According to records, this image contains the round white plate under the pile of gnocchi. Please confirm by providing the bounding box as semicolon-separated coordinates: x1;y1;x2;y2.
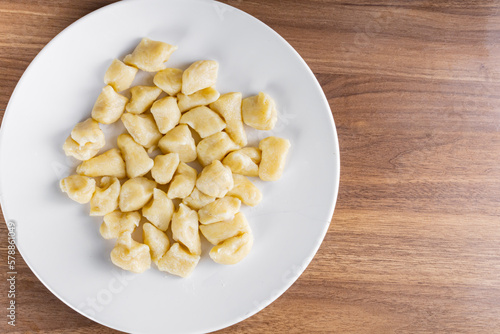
0;0;339;333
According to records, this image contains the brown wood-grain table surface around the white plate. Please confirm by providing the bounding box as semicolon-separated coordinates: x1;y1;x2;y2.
0;0;500;333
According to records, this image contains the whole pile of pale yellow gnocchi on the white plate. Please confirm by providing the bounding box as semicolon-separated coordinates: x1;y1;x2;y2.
60;38;290;277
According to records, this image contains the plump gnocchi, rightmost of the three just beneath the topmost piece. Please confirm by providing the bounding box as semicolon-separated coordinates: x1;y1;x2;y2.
182;60;219;95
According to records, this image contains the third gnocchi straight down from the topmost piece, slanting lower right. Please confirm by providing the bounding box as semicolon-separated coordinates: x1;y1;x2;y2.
121;113;161;148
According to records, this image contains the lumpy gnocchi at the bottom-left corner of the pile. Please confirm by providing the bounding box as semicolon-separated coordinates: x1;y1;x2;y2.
111;233;151;273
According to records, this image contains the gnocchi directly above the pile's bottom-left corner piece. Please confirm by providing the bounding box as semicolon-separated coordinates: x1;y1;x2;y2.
99;210;141;239
